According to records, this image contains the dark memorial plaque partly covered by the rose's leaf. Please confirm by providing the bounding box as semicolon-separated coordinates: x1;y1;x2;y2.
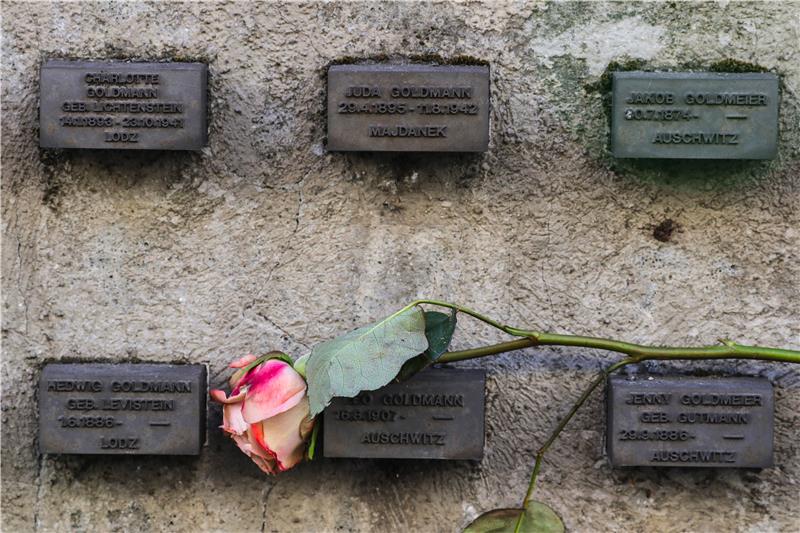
323;369;486;460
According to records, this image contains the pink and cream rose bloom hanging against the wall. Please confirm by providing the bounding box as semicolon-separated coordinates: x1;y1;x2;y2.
211;355;314;474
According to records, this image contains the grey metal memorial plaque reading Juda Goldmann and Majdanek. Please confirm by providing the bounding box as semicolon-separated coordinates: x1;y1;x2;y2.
328;65;489;152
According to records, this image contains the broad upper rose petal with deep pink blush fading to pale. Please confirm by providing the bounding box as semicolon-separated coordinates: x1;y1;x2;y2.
240;359;306;424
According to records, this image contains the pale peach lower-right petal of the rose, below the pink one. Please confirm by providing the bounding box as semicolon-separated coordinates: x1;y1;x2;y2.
254;397;309;471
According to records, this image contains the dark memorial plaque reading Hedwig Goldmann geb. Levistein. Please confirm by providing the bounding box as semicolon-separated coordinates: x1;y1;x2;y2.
39;363;206;455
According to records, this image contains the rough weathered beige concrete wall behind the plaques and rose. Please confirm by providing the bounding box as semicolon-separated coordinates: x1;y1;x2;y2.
2;2;800;531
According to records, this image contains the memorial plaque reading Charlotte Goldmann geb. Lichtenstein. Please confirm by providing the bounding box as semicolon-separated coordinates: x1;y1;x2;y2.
39;59;207;150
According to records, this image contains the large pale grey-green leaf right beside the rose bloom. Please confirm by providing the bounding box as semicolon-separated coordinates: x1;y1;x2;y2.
306;306;428;416
